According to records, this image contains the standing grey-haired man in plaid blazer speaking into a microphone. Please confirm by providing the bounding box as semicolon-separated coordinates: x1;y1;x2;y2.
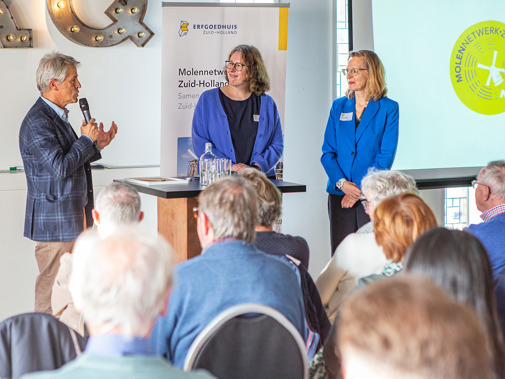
19;52;117;313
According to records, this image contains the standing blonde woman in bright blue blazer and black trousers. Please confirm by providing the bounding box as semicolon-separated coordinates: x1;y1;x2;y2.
321;50;399;255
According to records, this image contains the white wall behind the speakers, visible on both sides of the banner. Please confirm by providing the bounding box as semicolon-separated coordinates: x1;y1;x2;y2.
0;0;334;320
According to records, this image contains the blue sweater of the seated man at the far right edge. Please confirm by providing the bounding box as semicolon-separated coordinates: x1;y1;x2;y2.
466;213;505;275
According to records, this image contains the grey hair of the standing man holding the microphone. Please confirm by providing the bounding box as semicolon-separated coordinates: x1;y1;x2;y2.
36;51;80;95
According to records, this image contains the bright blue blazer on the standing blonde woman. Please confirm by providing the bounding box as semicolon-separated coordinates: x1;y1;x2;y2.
321;97;399;195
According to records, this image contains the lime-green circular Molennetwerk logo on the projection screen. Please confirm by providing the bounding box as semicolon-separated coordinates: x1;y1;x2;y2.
451;21;505;115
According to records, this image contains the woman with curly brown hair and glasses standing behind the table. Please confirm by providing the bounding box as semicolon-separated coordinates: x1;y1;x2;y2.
192;45;284;177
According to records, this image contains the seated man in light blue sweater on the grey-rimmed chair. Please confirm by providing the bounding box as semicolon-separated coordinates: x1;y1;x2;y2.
152;176;305;367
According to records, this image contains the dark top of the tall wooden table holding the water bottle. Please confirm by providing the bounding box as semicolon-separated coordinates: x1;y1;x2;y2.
114;178;307;199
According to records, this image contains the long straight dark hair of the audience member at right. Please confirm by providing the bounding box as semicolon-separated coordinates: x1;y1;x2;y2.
405;228;505;378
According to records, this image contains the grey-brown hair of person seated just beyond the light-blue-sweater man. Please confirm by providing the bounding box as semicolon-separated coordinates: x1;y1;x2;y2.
240;168;282;228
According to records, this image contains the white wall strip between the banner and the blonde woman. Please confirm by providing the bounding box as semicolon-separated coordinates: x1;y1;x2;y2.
283;0;335;277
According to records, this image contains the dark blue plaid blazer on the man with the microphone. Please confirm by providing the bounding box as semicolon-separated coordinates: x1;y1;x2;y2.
19;98;101;242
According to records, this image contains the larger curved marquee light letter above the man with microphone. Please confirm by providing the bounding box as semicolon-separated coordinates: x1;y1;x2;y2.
47;0;154;47
